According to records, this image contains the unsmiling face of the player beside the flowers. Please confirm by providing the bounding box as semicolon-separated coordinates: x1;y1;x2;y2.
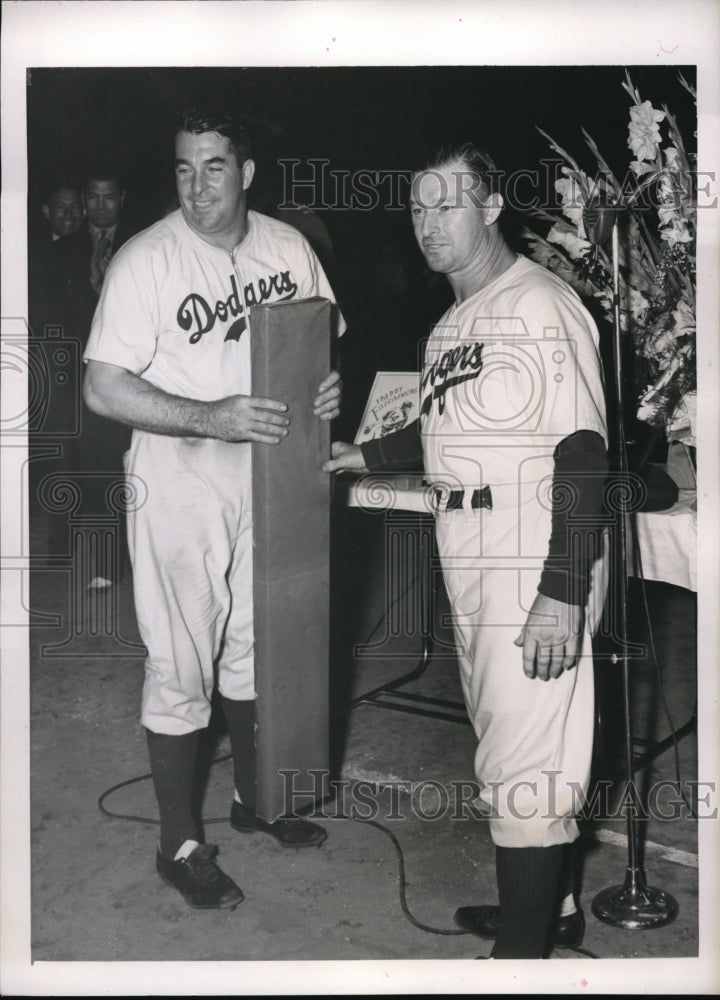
410;162;496;274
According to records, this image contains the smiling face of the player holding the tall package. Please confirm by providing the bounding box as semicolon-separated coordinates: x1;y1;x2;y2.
175;132;255;250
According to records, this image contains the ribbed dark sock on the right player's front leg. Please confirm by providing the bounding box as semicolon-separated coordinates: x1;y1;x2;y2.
492;844;565;958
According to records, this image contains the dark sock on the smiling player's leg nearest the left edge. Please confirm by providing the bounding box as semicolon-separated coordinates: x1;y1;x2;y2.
146;729;200;861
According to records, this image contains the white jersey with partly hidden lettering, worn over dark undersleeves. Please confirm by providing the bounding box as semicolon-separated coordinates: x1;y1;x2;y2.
420;256;607;487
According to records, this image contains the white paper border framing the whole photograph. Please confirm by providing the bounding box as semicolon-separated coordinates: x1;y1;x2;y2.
0;0;720;996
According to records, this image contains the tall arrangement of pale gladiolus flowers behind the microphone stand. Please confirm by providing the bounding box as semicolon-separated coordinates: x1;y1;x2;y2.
524;72;697;434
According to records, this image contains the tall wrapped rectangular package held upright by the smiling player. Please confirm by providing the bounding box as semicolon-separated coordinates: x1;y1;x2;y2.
250;298;331;822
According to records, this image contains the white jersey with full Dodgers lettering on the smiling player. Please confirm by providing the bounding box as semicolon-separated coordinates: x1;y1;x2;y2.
84;209;344;401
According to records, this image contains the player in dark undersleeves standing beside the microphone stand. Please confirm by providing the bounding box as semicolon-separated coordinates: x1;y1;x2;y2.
326;144;607;958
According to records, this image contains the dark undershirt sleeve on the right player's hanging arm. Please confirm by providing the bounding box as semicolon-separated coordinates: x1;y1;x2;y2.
538;431;608;606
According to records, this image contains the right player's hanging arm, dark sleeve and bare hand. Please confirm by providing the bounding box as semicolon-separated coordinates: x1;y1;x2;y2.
515;430;608;680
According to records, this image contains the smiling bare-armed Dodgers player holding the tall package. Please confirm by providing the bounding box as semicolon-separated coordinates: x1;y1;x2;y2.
85;108;342;908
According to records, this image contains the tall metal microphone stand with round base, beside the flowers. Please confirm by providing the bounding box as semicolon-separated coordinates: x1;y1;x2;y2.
583;200;678;930
